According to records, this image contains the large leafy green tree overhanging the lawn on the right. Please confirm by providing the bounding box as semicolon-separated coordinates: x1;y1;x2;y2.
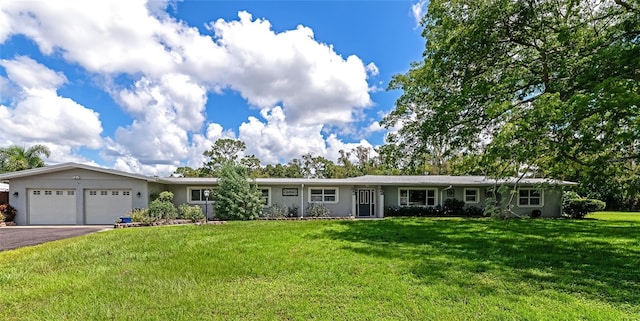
383;0;640;192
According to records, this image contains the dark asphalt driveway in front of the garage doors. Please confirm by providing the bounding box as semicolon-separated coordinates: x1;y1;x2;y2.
0;225;110;251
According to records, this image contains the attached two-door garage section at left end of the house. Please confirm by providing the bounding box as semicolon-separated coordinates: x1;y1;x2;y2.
0;163;154;225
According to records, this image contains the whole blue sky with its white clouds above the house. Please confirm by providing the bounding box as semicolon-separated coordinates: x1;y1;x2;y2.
0;0;426;175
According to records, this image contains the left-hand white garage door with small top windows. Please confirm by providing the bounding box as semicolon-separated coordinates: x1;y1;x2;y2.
29;189;76;224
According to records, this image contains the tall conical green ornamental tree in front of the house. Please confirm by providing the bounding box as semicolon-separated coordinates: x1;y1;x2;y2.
213;162;262;220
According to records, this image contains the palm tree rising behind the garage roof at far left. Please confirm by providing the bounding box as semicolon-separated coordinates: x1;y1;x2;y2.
0;145;51;172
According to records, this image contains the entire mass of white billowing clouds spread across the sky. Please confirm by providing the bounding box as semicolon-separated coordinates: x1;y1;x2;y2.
0;0;379;172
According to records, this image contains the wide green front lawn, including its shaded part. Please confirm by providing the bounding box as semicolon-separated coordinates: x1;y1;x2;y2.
0;214;640;320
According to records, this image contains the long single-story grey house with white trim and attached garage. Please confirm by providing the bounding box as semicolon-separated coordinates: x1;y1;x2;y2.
0;163;575;225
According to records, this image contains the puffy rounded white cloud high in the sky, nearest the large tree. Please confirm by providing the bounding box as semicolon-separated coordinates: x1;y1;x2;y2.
210;12;375;125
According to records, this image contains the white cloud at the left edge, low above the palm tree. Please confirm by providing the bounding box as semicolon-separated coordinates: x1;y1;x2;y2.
0;57;102;162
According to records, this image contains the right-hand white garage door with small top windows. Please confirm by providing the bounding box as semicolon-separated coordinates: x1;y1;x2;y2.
84;189;132;224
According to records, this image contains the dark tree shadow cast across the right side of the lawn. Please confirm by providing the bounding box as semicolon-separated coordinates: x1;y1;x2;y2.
321;219;640;305
